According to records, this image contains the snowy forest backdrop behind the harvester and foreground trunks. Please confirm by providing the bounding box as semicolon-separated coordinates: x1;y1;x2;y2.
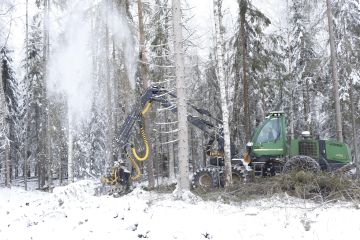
0;0;360;188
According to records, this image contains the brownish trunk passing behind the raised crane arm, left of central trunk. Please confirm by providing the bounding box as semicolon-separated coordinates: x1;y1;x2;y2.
137;0;155;189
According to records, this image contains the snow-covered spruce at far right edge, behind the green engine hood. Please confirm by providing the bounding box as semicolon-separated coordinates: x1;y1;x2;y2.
332;0;360;171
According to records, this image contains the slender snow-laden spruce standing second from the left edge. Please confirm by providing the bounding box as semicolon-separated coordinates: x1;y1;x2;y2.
21;14;46;188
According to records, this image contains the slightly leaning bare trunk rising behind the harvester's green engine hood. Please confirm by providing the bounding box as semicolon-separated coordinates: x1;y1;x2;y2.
326;0;343;142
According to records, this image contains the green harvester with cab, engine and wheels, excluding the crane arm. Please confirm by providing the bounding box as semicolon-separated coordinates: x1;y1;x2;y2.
192;112;352;188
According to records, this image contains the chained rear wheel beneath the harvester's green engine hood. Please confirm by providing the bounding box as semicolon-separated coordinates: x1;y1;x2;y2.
283;155;320;172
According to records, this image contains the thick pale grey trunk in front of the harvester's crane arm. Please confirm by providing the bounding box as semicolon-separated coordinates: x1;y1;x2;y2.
172;0;190;192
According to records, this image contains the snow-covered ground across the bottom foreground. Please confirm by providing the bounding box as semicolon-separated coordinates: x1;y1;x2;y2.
0;181;360;240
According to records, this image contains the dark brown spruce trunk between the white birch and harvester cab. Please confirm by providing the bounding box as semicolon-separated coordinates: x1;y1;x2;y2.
239;0;251;142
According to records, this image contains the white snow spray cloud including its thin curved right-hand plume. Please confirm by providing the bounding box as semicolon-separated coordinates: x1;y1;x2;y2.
48;0;137;124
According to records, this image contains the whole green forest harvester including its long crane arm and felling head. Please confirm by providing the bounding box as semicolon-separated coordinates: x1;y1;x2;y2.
102;86;352;192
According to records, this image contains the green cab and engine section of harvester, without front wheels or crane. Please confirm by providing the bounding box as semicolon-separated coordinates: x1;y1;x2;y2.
244;112;352;175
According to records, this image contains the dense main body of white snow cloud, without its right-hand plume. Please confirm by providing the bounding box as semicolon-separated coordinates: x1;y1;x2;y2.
48;1;93;123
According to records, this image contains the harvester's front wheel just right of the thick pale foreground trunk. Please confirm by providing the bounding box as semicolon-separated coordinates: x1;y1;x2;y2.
192;167;219;189
